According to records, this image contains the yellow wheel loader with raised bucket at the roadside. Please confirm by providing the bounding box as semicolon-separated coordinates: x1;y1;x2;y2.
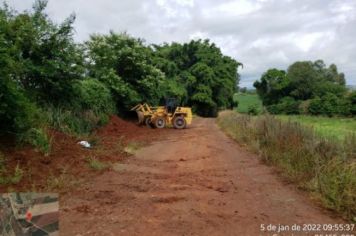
131;98;193;129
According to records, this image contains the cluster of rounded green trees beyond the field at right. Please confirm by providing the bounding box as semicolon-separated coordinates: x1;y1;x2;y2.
254;60;356;116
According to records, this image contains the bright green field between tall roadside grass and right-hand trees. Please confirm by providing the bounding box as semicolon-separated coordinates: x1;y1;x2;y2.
277;115;356;140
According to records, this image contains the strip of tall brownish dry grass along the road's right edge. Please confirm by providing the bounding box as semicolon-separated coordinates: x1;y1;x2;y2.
218;112;356;219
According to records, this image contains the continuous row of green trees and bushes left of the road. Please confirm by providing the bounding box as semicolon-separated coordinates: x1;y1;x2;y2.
0;0;241;144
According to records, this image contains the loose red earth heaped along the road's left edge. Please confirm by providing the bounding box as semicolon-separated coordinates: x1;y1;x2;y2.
0;116;167;192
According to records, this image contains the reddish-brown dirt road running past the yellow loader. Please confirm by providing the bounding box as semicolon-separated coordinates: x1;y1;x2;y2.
60;118;340;236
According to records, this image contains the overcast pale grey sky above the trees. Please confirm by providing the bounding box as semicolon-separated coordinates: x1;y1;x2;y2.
0;0;356;87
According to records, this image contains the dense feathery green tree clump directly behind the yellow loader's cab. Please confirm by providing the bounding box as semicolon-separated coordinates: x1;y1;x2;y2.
154;40;242;116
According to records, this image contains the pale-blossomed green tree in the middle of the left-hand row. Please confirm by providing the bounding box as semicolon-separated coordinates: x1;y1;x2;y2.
85;32;165;113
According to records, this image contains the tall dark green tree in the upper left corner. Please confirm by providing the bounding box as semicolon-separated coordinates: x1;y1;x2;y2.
0;0;84;104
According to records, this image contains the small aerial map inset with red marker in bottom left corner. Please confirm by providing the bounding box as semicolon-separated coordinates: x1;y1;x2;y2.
0;193;59;236
